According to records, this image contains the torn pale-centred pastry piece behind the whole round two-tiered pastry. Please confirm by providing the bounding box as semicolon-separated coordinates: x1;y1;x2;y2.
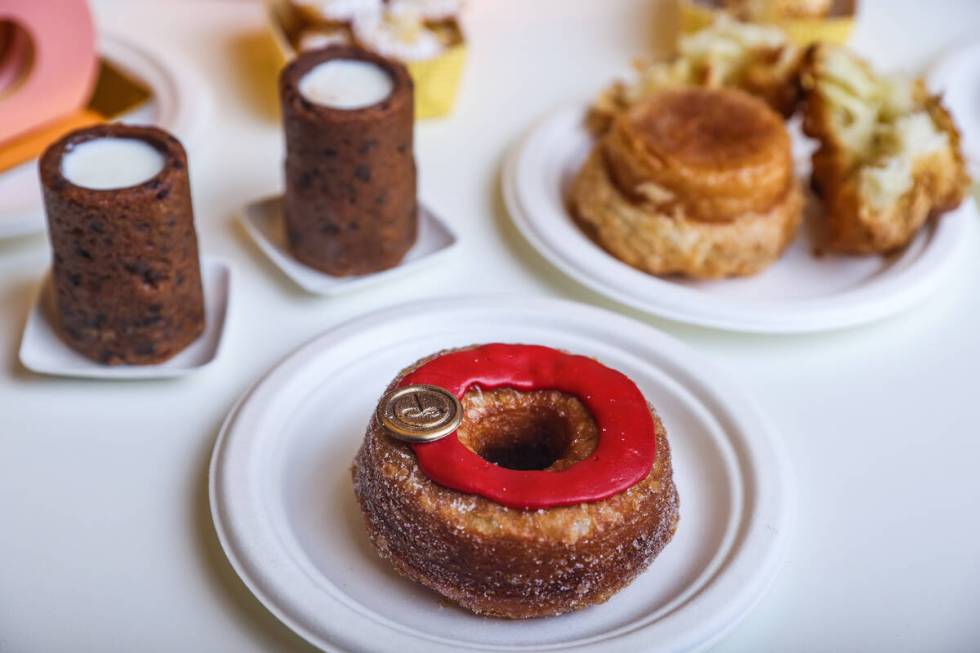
591;14;802;132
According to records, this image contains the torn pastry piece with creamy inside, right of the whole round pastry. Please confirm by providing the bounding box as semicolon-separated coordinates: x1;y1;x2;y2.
801;44;969;254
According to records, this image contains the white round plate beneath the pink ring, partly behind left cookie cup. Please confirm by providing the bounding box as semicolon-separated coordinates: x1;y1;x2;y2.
0;30;209;240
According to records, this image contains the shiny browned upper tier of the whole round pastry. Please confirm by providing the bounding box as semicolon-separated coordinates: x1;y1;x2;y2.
601;88;793;222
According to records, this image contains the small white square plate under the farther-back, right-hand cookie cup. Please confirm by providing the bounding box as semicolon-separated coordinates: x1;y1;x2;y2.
241;196;456;295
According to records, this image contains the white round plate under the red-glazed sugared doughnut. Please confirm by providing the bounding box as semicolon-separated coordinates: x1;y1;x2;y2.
210;297;793;653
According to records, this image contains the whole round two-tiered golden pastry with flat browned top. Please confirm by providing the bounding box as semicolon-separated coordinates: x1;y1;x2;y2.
571;88;803;279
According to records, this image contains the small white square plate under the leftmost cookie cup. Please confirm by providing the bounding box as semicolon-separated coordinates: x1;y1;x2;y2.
20;260;231;379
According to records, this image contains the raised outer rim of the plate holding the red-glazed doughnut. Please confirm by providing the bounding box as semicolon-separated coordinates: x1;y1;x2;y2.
208;294;796;653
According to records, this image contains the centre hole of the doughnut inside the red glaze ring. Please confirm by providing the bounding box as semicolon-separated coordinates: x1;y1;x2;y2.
456;388;599;472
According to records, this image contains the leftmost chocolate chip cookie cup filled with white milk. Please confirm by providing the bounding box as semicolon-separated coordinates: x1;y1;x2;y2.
40;124;205;365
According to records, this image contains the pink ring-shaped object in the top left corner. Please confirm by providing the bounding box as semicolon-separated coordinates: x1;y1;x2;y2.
0;0;98;143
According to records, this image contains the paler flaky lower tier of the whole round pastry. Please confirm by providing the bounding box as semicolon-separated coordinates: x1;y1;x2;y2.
571;150;803;279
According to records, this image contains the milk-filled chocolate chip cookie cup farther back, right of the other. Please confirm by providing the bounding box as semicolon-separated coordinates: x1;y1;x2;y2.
279;46;418;276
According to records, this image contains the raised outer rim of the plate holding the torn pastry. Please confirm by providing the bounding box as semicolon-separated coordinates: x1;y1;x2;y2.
500;103;977;334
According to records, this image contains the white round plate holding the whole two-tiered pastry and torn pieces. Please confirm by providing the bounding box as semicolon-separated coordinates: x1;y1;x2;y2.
503;108;976;333
